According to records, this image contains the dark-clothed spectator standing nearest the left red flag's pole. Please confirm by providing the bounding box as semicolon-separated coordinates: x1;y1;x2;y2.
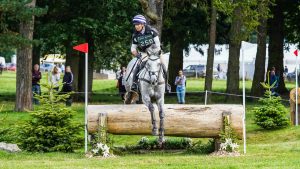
62;66;73;106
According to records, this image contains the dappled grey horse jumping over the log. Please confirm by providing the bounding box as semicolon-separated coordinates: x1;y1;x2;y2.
125;53;165;146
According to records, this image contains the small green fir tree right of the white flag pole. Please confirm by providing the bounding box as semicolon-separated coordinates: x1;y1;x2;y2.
253;91;290;129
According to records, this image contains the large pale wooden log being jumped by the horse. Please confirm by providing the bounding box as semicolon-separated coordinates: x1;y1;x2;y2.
88;104;243;138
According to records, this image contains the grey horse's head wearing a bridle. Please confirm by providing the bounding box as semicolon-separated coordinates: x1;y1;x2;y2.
145;54;162;85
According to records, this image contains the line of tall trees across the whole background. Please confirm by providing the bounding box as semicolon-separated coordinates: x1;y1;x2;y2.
0;0;300;111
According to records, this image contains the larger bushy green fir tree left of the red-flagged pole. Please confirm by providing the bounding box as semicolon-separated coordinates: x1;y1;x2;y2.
19;84;82;152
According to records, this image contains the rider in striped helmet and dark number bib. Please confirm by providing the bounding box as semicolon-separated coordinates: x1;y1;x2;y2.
131;15;167;92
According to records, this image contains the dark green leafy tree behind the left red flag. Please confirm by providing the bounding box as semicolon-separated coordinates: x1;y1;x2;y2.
34;0;141;100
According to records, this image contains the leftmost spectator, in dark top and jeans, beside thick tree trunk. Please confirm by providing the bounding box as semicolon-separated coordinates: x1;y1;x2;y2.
32;64;42;105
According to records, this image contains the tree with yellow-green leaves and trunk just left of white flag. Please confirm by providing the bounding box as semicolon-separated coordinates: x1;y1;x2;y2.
216;0;272;100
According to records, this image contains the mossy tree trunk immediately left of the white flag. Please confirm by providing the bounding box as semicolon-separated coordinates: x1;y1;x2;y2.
226;4;242;101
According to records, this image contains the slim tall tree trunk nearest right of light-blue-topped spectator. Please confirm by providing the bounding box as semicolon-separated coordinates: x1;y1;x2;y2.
204;0;217;103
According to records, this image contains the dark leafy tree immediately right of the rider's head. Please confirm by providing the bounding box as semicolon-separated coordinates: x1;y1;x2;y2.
162;0;208;91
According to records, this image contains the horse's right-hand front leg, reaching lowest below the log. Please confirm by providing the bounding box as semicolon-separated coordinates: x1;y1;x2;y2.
156;95;165;146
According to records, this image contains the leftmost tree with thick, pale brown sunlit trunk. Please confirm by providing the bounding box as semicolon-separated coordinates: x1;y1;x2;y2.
6;0;43;111
